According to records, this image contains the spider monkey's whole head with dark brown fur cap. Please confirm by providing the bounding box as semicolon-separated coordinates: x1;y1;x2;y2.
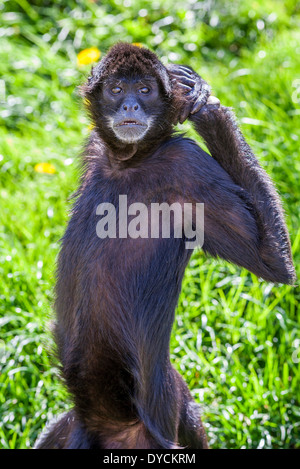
81;43;180;159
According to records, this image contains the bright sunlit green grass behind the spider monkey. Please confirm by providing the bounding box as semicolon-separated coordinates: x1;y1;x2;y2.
0;0;300;448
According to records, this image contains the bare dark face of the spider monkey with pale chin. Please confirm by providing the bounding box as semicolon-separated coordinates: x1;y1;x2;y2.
101;77;162;143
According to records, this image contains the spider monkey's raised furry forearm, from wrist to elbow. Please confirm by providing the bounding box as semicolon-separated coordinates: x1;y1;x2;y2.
190;98;295;284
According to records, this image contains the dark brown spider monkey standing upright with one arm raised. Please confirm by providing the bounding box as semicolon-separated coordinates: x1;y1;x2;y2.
36;43;295;449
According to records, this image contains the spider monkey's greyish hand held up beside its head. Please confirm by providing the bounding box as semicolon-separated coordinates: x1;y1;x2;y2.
168;64;214;124
